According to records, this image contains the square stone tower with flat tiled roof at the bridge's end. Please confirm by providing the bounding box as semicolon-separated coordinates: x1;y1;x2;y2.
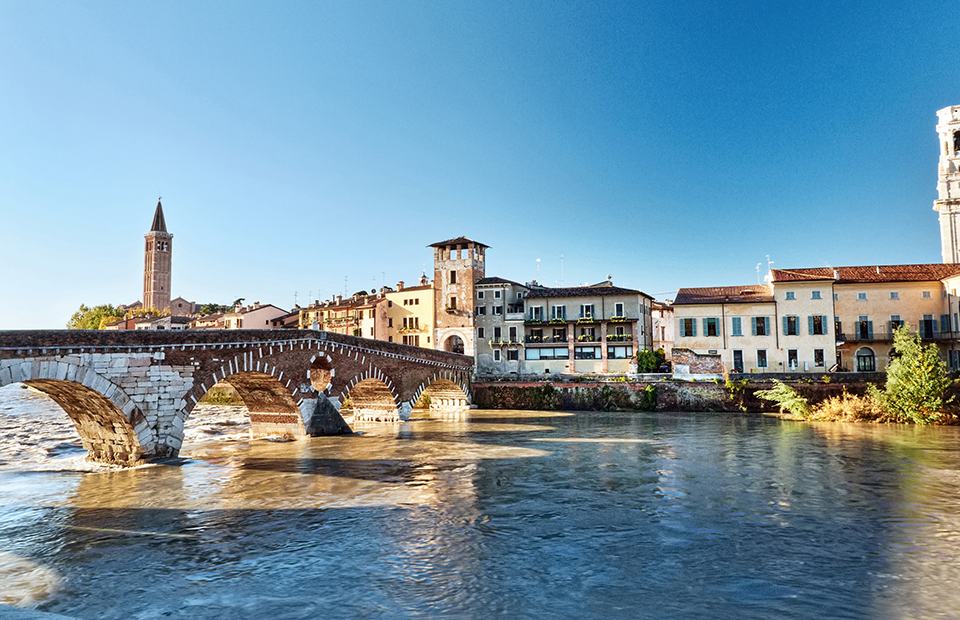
430;237;488;357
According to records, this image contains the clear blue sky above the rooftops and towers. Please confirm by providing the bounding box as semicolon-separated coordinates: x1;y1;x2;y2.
0;0;960;329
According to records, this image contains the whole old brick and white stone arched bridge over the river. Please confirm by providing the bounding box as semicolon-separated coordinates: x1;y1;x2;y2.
0;329;473;465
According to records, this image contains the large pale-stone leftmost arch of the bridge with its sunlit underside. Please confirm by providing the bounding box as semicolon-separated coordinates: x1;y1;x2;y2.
0;361;150;466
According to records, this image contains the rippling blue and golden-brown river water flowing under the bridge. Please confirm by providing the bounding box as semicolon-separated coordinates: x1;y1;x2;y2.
0;386;960;620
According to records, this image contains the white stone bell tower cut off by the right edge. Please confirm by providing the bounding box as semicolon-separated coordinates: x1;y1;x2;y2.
933;106;960;263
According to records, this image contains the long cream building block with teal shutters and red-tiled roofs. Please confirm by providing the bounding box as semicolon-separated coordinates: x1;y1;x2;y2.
673;264;960;373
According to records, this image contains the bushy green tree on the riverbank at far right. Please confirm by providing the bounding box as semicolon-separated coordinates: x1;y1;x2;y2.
870;325;953;424
